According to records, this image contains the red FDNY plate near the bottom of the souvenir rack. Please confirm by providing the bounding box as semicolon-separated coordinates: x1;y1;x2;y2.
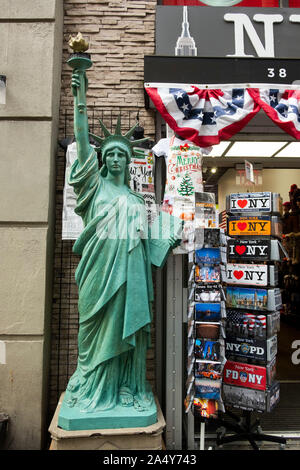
223;361;267;390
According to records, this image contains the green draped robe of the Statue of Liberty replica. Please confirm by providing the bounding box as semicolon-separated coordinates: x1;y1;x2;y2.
65;149;153;411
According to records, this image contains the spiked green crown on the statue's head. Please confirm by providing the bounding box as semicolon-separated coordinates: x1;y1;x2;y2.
89;116;148;157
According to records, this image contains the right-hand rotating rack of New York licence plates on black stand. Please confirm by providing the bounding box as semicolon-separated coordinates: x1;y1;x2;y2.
217;193;286;450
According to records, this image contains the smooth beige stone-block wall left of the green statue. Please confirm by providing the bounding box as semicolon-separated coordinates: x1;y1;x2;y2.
0;0;63;450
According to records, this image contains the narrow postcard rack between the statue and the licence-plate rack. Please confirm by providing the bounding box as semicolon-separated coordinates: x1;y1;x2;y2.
184;193;226;449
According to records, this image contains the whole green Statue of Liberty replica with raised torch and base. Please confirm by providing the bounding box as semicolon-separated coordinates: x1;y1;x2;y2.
58;34;181;430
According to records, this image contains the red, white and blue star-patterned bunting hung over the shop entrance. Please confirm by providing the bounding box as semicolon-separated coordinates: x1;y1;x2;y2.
145;84;300;147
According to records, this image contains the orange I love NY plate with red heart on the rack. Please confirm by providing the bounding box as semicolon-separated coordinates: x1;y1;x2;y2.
228;216;272;236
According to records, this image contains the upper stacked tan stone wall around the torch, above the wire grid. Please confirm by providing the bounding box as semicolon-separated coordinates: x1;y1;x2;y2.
61;0;156;136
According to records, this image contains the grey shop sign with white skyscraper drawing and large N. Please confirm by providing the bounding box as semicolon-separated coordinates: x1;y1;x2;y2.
156;6;300;59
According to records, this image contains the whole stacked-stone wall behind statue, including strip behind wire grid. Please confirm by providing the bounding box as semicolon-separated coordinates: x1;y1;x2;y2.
49;0;156;420
